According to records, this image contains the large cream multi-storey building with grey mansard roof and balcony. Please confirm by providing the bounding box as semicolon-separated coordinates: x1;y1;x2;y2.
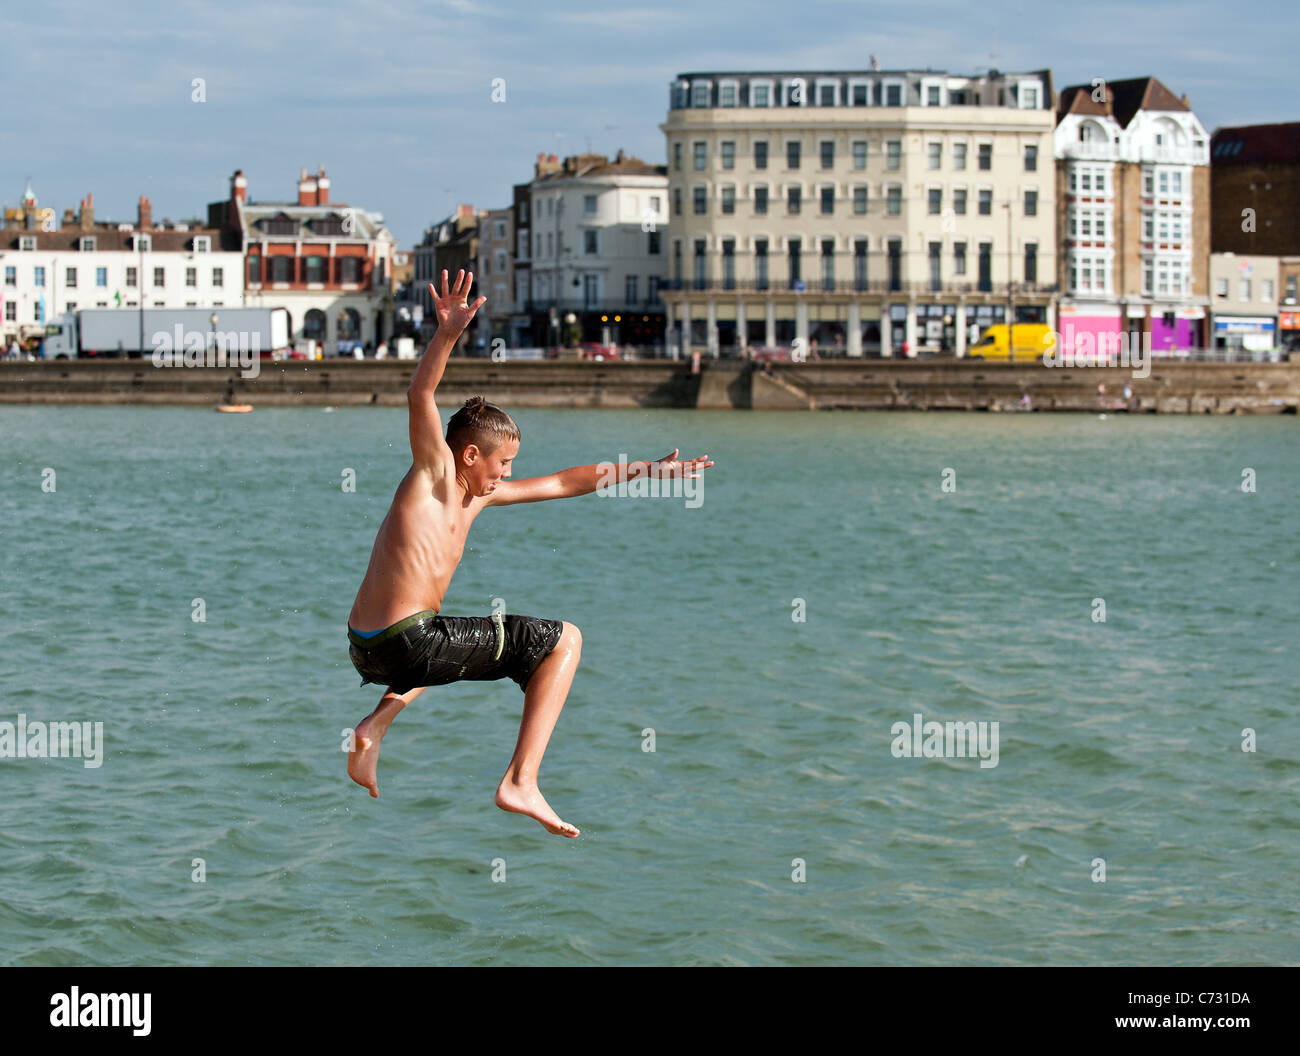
660;69;1057;356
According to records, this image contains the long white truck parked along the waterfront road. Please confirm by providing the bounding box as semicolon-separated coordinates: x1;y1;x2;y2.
44;308;291;359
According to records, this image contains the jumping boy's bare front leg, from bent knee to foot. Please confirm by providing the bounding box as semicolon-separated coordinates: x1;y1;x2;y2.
493;623;582;838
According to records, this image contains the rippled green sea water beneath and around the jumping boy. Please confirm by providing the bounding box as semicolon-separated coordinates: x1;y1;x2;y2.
0;407;1300;965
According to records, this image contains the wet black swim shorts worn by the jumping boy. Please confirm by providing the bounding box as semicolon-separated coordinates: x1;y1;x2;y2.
347;609;564;693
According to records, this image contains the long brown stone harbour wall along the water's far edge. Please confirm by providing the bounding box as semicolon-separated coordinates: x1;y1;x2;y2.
0;359;1300;414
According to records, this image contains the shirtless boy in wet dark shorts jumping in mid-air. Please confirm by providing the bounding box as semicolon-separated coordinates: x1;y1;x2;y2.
347;271;714;836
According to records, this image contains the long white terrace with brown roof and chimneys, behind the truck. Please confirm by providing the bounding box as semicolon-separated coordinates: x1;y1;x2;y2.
0;185;244;342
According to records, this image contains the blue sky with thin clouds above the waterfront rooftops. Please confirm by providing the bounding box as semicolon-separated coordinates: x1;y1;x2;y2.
0;0;1300;246
